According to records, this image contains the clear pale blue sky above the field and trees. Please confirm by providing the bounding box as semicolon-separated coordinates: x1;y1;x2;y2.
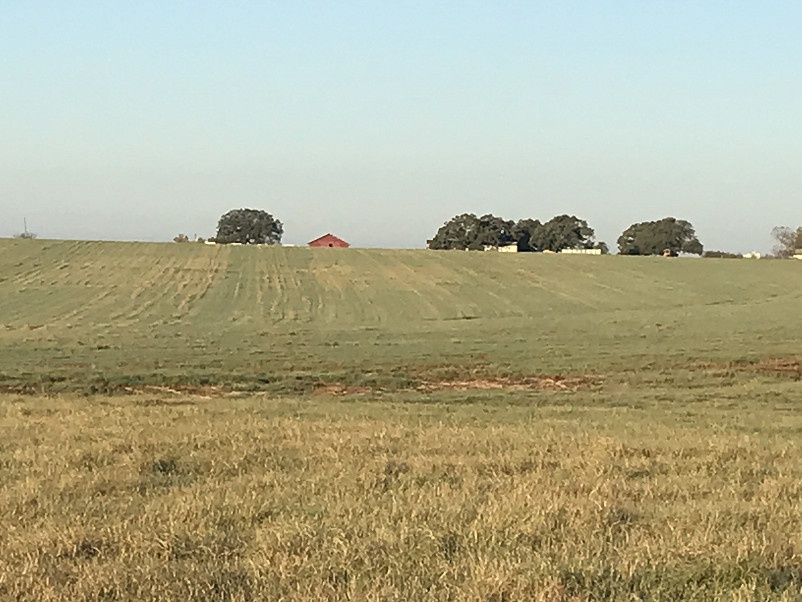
0;0;802;251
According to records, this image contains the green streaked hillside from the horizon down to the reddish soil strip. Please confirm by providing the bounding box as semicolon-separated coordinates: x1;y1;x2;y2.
0;239;802;392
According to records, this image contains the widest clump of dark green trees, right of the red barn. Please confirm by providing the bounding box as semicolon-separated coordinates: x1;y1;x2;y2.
428;213;607;252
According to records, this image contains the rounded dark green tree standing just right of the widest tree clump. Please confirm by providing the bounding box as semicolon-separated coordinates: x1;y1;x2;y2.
618;217;703;255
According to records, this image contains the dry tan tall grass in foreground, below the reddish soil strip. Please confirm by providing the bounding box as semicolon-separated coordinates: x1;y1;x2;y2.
0;385;802;602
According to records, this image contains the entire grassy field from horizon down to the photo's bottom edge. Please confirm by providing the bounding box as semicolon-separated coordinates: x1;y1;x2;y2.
0;240;802;602
